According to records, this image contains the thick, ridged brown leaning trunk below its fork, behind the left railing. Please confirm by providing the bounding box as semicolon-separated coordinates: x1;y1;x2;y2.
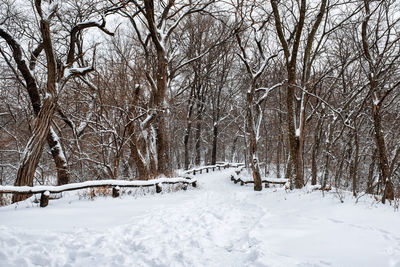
12;96;56;203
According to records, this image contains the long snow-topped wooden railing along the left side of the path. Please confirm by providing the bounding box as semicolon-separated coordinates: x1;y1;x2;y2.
0;163;244;207
